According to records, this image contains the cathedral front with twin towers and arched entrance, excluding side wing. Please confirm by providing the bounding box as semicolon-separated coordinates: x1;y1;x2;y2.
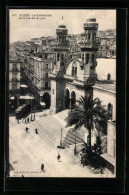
49;17;99;114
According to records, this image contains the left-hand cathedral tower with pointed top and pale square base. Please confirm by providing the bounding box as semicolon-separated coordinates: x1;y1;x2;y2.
49;17;68;114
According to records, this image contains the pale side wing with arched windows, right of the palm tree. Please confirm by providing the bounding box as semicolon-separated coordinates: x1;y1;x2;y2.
93;82;116;176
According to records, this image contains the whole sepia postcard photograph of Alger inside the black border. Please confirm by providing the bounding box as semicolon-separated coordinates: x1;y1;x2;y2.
8;9;117;178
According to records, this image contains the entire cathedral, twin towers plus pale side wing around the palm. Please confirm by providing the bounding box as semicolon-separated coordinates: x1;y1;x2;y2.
49;18;116;175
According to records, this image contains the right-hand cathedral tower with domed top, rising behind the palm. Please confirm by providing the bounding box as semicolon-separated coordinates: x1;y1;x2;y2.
81;15;99;86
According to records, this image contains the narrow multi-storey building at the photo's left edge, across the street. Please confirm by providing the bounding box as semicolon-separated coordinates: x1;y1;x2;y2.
9;59;21;109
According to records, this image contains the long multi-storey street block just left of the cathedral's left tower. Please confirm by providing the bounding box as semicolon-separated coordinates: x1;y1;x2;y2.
24;51;54;107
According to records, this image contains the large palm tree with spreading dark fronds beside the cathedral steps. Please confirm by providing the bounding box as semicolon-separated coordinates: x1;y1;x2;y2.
66;95;110;149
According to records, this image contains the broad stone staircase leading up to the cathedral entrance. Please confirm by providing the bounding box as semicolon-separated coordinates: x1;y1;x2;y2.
29;110;84;147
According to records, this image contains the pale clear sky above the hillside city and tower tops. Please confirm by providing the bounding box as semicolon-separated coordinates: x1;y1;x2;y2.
9;9;116;43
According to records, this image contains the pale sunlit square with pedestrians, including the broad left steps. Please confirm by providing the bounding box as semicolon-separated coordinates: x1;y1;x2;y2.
9;110;105;177
